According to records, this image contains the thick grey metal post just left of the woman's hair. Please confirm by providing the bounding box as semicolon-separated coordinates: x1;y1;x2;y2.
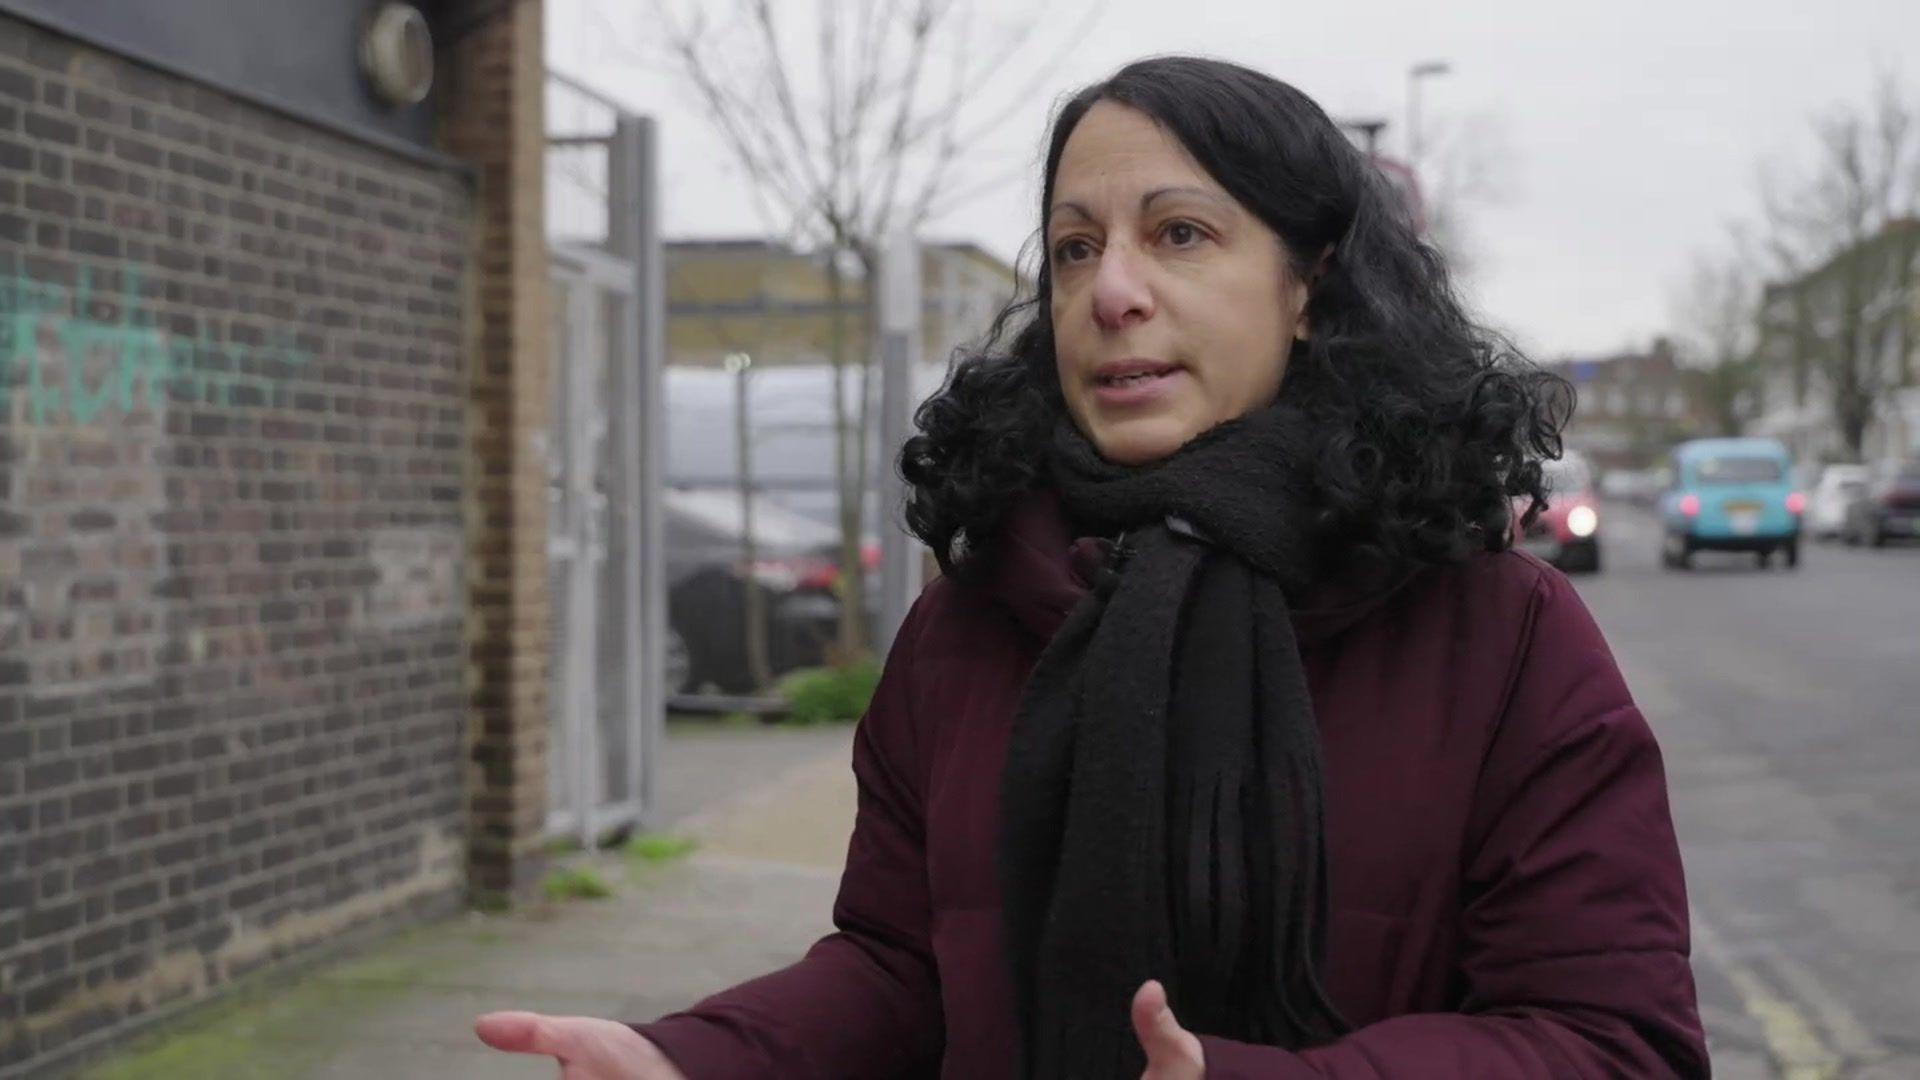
874;231;922;651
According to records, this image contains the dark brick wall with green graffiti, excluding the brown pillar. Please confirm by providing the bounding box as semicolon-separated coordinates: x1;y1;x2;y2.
0;15;474;1074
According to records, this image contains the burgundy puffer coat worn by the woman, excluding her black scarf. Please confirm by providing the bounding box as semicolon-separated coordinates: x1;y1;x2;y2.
636;496;1707;1080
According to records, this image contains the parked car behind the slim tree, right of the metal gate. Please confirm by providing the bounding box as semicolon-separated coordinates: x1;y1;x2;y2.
662;488;877;694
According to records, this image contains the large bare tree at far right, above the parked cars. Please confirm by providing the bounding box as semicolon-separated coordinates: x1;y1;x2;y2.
1761;73;1920;457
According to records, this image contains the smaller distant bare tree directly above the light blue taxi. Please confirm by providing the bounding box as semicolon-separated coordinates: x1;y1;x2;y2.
1672;236;1761;436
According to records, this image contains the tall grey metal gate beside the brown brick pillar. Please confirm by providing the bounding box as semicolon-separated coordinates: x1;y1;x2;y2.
547;75;666;847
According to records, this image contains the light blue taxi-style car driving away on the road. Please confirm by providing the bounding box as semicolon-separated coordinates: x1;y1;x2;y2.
1661;438;1807;569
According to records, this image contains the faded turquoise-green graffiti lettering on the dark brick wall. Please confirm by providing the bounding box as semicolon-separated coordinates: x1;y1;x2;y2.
0;271;313;425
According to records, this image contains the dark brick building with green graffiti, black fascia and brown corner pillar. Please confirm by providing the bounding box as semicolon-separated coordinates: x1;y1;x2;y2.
0;0;568;1076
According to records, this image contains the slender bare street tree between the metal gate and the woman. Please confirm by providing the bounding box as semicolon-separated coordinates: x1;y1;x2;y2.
651;0;1092;659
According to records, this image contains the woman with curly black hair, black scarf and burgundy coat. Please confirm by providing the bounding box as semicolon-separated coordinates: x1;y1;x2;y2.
482;58;1707;1080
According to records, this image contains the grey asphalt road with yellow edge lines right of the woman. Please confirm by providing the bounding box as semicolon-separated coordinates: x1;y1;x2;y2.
1574;507;1920;1080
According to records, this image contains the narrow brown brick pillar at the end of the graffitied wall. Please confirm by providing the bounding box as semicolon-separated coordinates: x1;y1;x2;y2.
442;0;553;907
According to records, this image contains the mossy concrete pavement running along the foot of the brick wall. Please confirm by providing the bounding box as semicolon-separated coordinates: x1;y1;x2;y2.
86;726;854;1080
